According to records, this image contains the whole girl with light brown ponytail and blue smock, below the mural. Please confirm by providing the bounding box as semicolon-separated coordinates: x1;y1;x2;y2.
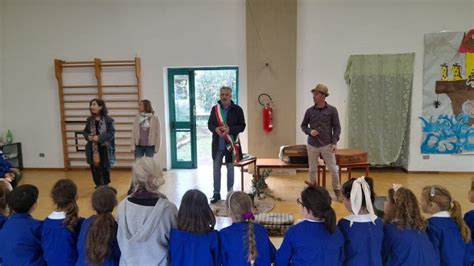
421;185;471;266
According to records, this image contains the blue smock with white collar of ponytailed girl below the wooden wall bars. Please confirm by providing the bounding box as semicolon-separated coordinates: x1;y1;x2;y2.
41;212;84;266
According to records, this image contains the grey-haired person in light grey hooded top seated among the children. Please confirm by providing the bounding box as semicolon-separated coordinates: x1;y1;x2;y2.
117;157;178;265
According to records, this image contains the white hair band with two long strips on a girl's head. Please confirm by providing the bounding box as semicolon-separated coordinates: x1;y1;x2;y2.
350;176;377;226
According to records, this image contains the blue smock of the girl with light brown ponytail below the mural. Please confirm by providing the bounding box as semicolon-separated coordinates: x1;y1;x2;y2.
426;211;466;266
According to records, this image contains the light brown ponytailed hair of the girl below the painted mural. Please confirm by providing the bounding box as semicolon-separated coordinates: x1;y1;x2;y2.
421;185;471;243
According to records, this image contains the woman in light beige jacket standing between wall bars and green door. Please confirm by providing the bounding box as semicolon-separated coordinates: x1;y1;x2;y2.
131;100;161;159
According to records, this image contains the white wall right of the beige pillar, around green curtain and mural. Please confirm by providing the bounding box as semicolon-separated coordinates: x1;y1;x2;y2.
295;0;474;171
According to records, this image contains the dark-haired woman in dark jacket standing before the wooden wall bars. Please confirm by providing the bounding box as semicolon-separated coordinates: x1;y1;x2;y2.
83;99;115;188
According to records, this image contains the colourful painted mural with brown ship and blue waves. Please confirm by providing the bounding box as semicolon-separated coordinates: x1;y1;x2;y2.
420;29;474;154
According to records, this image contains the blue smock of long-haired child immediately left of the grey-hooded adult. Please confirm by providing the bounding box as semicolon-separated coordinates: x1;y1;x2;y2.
76;215;120;266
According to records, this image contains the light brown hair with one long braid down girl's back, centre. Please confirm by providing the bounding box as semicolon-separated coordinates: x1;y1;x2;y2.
227;191;258;265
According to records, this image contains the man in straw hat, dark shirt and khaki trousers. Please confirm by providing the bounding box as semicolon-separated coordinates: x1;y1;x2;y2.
301;84;342;201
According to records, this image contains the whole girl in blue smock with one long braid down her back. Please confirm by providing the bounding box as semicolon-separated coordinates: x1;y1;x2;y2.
219;191;275;265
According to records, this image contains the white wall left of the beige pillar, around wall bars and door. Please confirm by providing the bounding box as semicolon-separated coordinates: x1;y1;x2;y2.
0;0;247;167
